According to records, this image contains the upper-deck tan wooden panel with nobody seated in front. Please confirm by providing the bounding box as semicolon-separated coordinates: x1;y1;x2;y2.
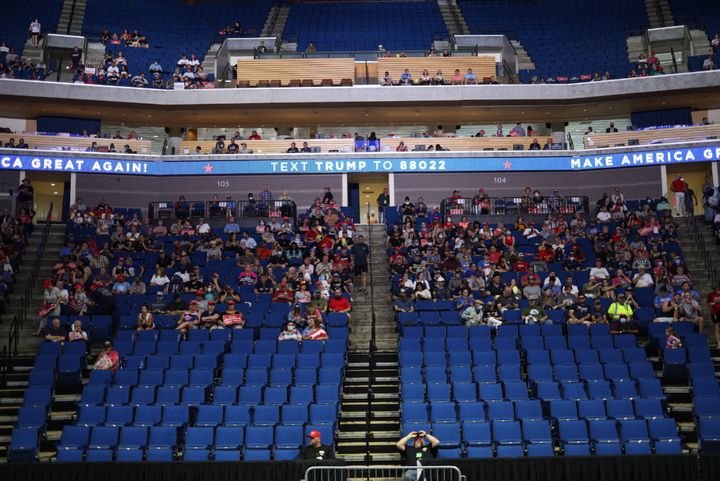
237;58;355;87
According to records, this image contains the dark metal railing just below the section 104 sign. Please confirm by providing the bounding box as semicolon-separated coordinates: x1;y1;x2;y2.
436;196;590;219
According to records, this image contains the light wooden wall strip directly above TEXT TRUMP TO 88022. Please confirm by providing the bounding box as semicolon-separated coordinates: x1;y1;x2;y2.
180;137;544;154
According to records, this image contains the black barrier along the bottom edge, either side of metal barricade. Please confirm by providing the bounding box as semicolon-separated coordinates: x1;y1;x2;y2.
0;454;720;481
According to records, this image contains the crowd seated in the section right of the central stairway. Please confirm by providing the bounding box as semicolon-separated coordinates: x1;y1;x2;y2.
387;187;720;344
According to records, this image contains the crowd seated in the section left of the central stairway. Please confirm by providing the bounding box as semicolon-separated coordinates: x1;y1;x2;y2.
36;186;370;342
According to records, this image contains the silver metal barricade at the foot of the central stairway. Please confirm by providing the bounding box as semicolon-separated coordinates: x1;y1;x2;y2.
304;466;466;481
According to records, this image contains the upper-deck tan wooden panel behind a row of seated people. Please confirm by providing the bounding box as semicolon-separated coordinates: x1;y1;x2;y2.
378;56;495;83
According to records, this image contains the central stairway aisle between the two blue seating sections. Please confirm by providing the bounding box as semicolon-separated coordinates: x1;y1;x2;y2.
336;225;400;464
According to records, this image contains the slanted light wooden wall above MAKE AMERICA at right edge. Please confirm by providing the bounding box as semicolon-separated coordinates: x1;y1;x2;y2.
583;125;720;148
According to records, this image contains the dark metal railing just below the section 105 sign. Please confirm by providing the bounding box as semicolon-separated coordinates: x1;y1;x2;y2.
148;200;297;224
